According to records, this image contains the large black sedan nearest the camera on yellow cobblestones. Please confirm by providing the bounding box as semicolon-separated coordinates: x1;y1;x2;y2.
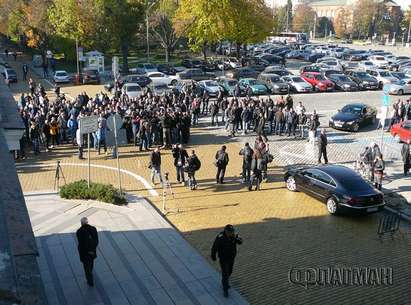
284;165;385;215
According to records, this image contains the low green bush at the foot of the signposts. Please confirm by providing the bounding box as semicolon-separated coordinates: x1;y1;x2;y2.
60;180;127;205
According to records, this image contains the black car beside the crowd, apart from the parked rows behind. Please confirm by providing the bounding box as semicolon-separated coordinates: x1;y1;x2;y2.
329;103;377;132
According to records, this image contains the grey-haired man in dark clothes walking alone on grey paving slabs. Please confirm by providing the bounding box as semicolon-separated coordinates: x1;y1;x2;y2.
76;217;98;286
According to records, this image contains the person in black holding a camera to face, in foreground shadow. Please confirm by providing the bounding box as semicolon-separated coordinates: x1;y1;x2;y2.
211;224;243;298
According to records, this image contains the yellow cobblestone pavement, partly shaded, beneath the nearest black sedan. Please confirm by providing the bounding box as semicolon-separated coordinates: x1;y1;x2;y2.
7;50;411;305
